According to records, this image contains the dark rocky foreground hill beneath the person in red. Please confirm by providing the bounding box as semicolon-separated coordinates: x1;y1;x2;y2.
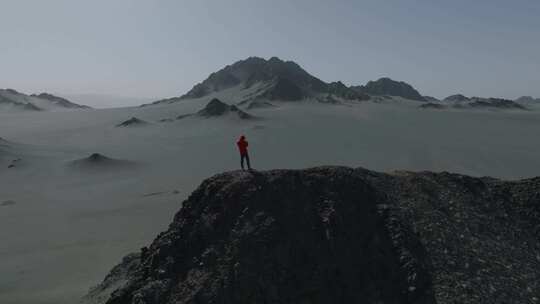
85;167;540;304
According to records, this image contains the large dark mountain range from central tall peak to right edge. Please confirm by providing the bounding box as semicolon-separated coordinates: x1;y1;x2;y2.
153;57;538;109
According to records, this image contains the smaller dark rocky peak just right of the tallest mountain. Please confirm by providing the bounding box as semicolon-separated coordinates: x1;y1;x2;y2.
351;77;426;101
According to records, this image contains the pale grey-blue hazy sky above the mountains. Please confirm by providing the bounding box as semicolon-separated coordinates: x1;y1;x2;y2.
0;0;540;103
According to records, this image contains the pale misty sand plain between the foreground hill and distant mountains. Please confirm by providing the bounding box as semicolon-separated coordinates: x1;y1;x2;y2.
0;92;540;304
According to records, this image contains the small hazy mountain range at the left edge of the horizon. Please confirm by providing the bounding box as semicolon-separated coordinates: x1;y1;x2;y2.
0;89;90;112
